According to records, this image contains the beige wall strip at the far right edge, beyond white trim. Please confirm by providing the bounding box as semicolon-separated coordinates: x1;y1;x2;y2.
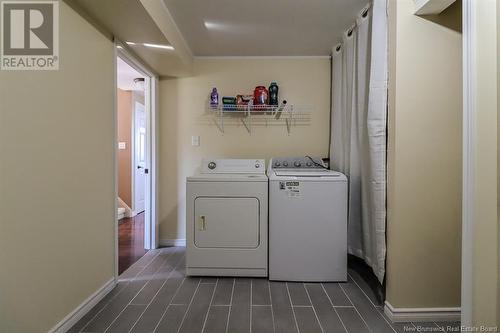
472;0;500;325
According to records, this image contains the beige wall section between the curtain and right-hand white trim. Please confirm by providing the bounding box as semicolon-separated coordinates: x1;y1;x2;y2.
386;0;462;308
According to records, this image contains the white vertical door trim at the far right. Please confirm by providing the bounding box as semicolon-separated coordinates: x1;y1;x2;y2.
461;0;477;326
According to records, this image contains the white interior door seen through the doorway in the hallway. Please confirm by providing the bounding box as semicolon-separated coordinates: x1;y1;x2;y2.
134;102;147;214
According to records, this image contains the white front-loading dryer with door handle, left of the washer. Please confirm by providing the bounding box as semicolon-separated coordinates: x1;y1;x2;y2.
186;159;268;276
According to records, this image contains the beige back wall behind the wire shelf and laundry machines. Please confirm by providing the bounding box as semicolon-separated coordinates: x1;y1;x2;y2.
159;58;330;239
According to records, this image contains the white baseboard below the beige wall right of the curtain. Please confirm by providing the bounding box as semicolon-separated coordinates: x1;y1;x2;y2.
384;301;460;322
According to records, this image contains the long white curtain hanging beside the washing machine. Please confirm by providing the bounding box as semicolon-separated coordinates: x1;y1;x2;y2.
330;0;388;282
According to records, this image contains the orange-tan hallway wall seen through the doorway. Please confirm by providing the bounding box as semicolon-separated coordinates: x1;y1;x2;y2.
116;89;132;207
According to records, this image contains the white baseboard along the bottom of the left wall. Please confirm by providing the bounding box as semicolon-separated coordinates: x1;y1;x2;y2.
48;278;116;333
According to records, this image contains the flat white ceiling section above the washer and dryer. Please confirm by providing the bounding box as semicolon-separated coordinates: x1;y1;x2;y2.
163;0;369;56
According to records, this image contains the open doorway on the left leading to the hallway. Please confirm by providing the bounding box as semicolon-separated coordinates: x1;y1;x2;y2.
115;43;157;276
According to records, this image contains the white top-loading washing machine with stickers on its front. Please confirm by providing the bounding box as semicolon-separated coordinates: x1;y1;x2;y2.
267;157;347;282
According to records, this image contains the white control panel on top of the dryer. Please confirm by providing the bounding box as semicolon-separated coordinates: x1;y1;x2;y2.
201;159;266;174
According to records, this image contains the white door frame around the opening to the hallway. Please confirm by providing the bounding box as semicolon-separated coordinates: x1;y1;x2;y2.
113;40;159;278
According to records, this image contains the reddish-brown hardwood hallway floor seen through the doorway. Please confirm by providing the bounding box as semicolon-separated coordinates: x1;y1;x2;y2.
118;212;147;274
